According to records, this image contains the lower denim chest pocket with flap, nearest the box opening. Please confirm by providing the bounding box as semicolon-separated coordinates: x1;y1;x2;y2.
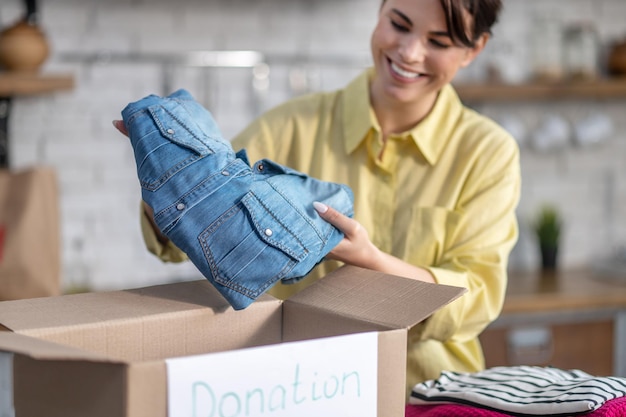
198;188;308;298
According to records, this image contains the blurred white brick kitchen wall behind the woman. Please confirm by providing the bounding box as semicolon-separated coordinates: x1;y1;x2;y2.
0;0;626;290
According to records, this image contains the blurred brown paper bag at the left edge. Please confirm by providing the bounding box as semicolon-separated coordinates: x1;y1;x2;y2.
0;167;61;301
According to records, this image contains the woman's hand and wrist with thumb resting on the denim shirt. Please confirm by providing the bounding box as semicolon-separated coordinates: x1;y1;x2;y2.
313;202;435;282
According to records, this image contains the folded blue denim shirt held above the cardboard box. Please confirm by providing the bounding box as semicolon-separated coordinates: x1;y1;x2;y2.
122;90;353;310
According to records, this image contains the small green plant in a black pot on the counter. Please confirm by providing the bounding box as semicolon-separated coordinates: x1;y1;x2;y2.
534;205;562;270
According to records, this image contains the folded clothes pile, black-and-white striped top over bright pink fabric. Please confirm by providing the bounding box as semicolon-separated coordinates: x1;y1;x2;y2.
406;366;626;417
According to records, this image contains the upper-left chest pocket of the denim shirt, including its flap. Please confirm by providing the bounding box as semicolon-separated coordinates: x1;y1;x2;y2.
135;105;213;191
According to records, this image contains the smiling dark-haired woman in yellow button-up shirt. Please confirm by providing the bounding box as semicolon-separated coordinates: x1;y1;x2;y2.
135;0;520;404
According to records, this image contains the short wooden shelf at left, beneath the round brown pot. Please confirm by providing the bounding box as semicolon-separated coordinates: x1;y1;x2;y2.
0;72;74;97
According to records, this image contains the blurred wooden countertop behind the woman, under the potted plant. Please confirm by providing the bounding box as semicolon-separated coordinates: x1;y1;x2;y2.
502;268;626;314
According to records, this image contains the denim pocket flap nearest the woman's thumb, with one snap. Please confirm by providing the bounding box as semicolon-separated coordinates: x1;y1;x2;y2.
241;192;308;261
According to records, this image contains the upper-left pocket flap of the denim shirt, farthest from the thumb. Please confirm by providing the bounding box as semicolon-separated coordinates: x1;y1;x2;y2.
148;105;213;156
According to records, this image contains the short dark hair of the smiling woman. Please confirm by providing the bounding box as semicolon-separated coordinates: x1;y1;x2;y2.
382;0;502;47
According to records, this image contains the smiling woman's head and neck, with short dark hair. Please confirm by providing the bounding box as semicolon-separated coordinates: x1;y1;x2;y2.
371;0;499;134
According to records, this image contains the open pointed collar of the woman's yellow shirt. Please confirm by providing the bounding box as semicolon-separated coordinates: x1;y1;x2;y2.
343;68;463;165
